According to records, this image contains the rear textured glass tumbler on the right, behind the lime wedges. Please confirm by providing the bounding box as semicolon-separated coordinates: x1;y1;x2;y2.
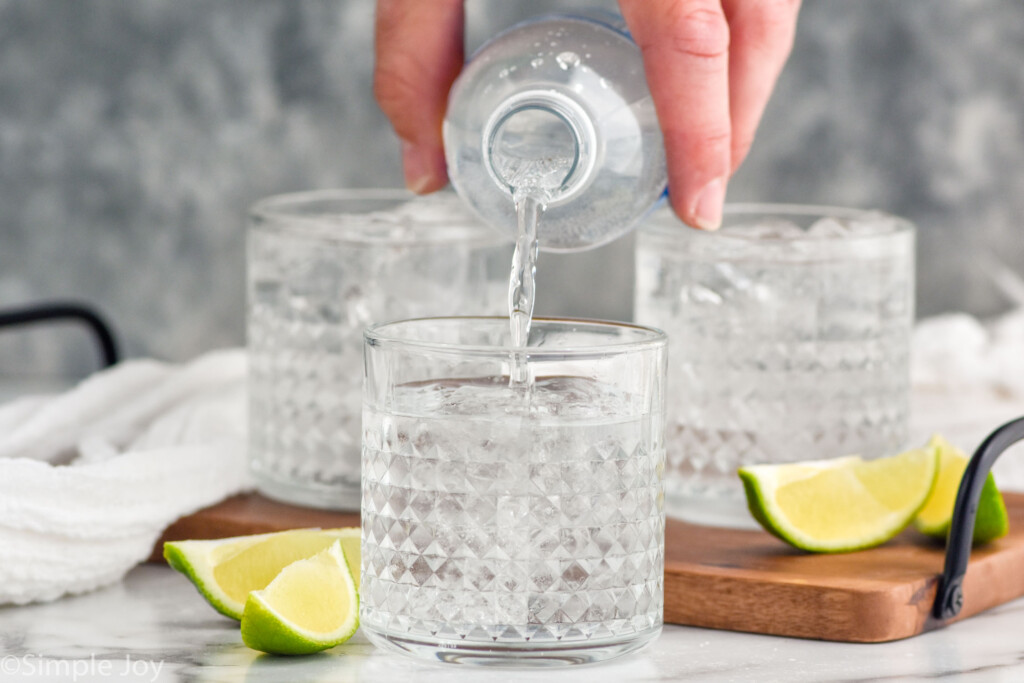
635;205;914;526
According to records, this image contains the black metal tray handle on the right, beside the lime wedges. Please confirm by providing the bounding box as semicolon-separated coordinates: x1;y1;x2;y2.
932;418;1024;621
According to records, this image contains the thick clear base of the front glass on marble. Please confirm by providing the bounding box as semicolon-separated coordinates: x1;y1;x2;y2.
362;625;662;669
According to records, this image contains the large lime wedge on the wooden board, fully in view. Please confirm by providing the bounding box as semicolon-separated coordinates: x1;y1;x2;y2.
739;449;938;553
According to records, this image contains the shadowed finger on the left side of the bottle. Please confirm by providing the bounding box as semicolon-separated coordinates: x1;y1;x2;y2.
374;0;464;194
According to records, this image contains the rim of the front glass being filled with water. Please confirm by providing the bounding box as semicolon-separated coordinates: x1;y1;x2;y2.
362;315;669;359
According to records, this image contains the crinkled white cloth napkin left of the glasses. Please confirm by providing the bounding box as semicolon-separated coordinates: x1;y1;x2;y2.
0;349;249;604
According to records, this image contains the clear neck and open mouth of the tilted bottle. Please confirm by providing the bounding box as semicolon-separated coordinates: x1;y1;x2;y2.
482;89;597;206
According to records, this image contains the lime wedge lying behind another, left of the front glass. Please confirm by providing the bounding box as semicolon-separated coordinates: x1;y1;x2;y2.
164;527;359;620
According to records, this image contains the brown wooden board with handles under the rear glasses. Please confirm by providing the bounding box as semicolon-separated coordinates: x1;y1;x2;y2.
151;494;1024;642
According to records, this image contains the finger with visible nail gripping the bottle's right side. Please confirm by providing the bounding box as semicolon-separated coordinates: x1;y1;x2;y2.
618;0;733;229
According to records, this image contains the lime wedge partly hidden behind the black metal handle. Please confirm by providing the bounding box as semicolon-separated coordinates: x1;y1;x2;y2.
913;434;1010;544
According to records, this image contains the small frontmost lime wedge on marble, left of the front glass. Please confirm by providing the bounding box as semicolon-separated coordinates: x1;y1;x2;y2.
242;541;359;654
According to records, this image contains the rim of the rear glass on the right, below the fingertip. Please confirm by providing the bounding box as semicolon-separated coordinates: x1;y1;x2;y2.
640;202;915;244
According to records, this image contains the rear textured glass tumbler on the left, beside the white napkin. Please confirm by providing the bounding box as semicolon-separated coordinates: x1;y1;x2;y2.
248;189;512;510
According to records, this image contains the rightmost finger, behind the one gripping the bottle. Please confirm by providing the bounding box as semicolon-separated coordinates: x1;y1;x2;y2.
722;0;800;172
